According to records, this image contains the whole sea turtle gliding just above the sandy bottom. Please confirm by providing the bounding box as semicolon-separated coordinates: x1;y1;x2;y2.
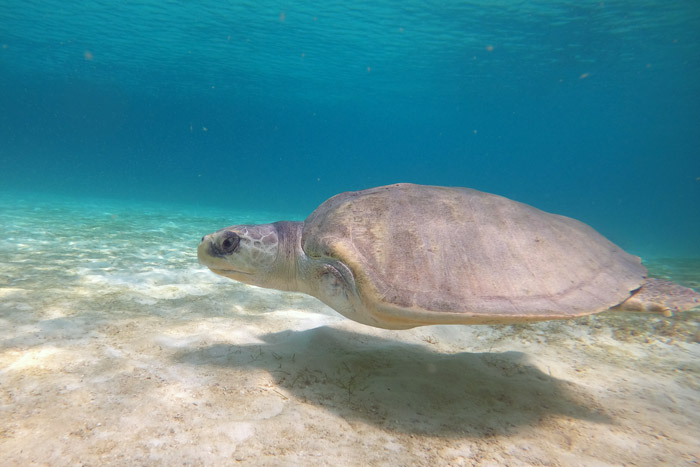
197;183;700;329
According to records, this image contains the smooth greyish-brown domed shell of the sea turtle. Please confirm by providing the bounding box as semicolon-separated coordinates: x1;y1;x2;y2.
301;184;646;324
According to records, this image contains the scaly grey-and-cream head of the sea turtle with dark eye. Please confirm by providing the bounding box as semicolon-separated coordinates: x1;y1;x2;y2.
197;222;300;290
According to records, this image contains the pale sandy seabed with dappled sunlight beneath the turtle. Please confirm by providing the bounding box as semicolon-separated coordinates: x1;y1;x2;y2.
0;194;700;466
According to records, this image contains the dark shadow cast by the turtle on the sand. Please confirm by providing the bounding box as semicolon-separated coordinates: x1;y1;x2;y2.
173;327;611;437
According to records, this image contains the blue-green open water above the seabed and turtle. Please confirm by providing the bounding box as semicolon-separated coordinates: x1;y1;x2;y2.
0;0;700;257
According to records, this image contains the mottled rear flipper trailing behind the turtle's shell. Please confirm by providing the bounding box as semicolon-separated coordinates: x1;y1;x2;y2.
612;278;700;316
